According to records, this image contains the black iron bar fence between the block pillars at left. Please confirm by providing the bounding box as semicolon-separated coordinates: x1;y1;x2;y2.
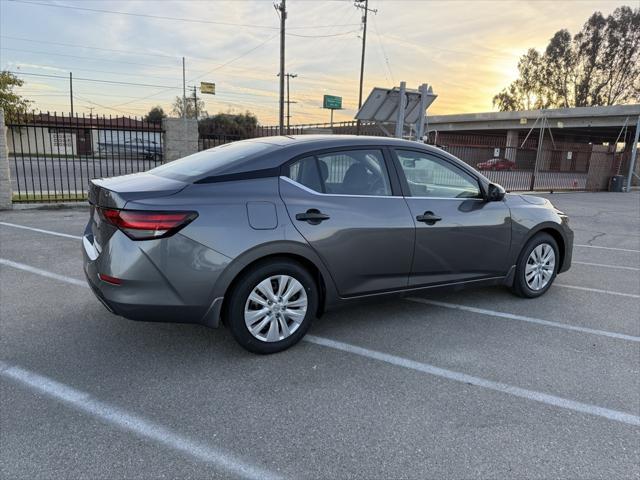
7;113;163;202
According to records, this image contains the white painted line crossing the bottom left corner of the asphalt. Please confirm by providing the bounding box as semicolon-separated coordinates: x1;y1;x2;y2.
0;361;280;479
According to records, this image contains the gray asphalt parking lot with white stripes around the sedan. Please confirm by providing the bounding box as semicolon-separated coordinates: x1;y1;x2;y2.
0;192;640;479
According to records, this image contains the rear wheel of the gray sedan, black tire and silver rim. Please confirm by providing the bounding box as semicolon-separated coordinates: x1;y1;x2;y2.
226;258;318;354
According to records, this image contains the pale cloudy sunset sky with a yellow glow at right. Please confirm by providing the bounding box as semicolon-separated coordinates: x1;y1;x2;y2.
0;0;639;125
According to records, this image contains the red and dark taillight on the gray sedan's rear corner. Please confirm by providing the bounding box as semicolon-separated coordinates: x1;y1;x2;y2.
99;208;198;240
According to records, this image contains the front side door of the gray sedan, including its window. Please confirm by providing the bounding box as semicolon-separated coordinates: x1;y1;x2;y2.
394;149;511;286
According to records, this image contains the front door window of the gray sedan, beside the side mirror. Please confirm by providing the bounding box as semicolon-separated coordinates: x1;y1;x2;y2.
396;150;480;198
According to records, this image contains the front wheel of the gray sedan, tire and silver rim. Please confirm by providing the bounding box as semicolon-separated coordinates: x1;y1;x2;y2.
512;233;560;298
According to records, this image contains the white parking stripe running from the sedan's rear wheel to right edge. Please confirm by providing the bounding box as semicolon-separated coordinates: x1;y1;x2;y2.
303;335;640;426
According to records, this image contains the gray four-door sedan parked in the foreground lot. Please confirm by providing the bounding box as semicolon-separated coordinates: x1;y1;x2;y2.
83;135;573;353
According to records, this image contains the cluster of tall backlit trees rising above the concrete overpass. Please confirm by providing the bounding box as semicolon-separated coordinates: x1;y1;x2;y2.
493;6;640;111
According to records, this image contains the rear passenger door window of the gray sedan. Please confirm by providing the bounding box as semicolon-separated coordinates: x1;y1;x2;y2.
287;150;391;196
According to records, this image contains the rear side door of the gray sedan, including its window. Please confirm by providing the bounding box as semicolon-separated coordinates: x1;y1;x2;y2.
280;148;415;297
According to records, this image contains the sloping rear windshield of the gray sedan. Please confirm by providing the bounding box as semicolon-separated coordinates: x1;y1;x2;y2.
149;142;275;182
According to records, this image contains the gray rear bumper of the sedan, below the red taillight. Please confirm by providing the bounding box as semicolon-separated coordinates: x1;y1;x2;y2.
82;231;223;328
